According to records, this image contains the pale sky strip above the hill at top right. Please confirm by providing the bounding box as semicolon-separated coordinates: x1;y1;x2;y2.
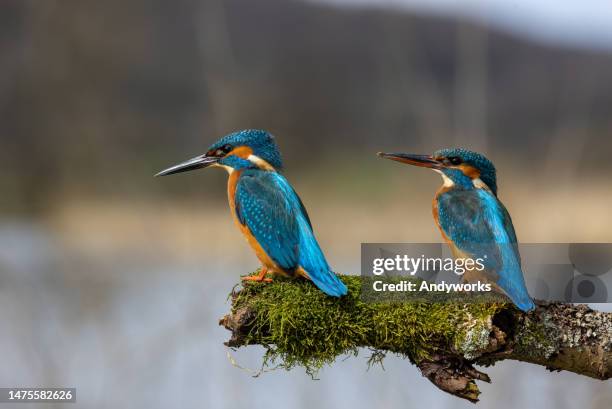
314;0;612;51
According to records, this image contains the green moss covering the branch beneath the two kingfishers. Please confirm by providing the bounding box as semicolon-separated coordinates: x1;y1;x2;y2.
233;276;508;374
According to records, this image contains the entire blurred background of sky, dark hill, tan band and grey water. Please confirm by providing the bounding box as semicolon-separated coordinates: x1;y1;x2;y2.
0;0;612;408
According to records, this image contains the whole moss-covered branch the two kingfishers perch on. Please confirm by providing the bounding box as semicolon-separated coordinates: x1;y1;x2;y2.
220;276;612;402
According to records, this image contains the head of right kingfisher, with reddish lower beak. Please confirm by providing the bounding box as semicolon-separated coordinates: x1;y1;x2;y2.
378;148;497;195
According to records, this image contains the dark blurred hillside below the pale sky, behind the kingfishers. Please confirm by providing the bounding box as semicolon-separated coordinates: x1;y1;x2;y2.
0;0;612;215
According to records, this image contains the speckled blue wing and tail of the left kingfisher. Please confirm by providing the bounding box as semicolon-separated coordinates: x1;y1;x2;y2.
235;170;347;297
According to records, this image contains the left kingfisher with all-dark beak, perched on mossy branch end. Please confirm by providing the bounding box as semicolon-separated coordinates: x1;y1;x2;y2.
155;129;348;297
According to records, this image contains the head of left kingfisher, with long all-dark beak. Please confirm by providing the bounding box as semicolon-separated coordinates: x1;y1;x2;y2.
155;129;283;176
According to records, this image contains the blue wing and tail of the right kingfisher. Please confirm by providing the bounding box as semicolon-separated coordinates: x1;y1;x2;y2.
437;189;535;311
